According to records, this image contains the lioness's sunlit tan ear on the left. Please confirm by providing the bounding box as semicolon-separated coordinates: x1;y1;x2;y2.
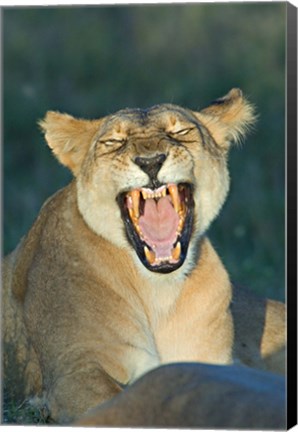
39;111;102;175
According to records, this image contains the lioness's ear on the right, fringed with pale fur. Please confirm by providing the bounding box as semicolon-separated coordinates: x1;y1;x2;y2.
195;89;256;148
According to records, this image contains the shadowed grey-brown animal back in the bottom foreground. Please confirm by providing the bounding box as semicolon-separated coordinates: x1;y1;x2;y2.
76;363;286;431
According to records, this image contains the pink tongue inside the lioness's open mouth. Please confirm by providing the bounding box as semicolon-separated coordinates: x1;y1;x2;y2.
139;196;179;258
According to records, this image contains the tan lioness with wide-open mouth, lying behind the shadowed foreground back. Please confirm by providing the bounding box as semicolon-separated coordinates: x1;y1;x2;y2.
3;89;285;423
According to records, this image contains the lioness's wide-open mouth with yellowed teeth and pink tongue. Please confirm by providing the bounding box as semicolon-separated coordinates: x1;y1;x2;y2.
117;183;194;273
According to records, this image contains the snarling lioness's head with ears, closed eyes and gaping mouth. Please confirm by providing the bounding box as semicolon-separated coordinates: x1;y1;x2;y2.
41;89;254;273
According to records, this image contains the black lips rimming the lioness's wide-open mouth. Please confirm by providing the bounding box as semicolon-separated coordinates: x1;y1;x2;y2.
116;183;194;274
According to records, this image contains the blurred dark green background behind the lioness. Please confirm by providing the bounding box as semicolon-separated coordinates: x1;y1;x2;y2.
2;2;286;300
